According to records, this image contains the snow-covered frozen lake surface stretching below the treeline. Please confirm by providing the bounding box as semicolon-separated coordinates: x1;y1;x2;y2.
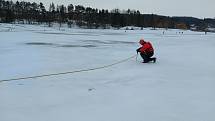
0;23;215;121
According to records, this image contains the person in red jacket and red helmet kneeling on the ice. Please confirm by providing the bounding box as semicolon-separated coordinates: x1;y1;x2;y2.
136;39;156;63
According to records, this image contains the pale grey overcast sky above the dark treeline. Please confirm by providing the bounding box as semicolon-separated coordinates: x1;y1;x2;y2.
18;0;215;18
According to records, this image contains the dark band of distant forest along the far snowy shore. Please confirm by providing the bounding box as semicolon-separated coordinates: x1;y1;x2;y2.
0;0;215;31
